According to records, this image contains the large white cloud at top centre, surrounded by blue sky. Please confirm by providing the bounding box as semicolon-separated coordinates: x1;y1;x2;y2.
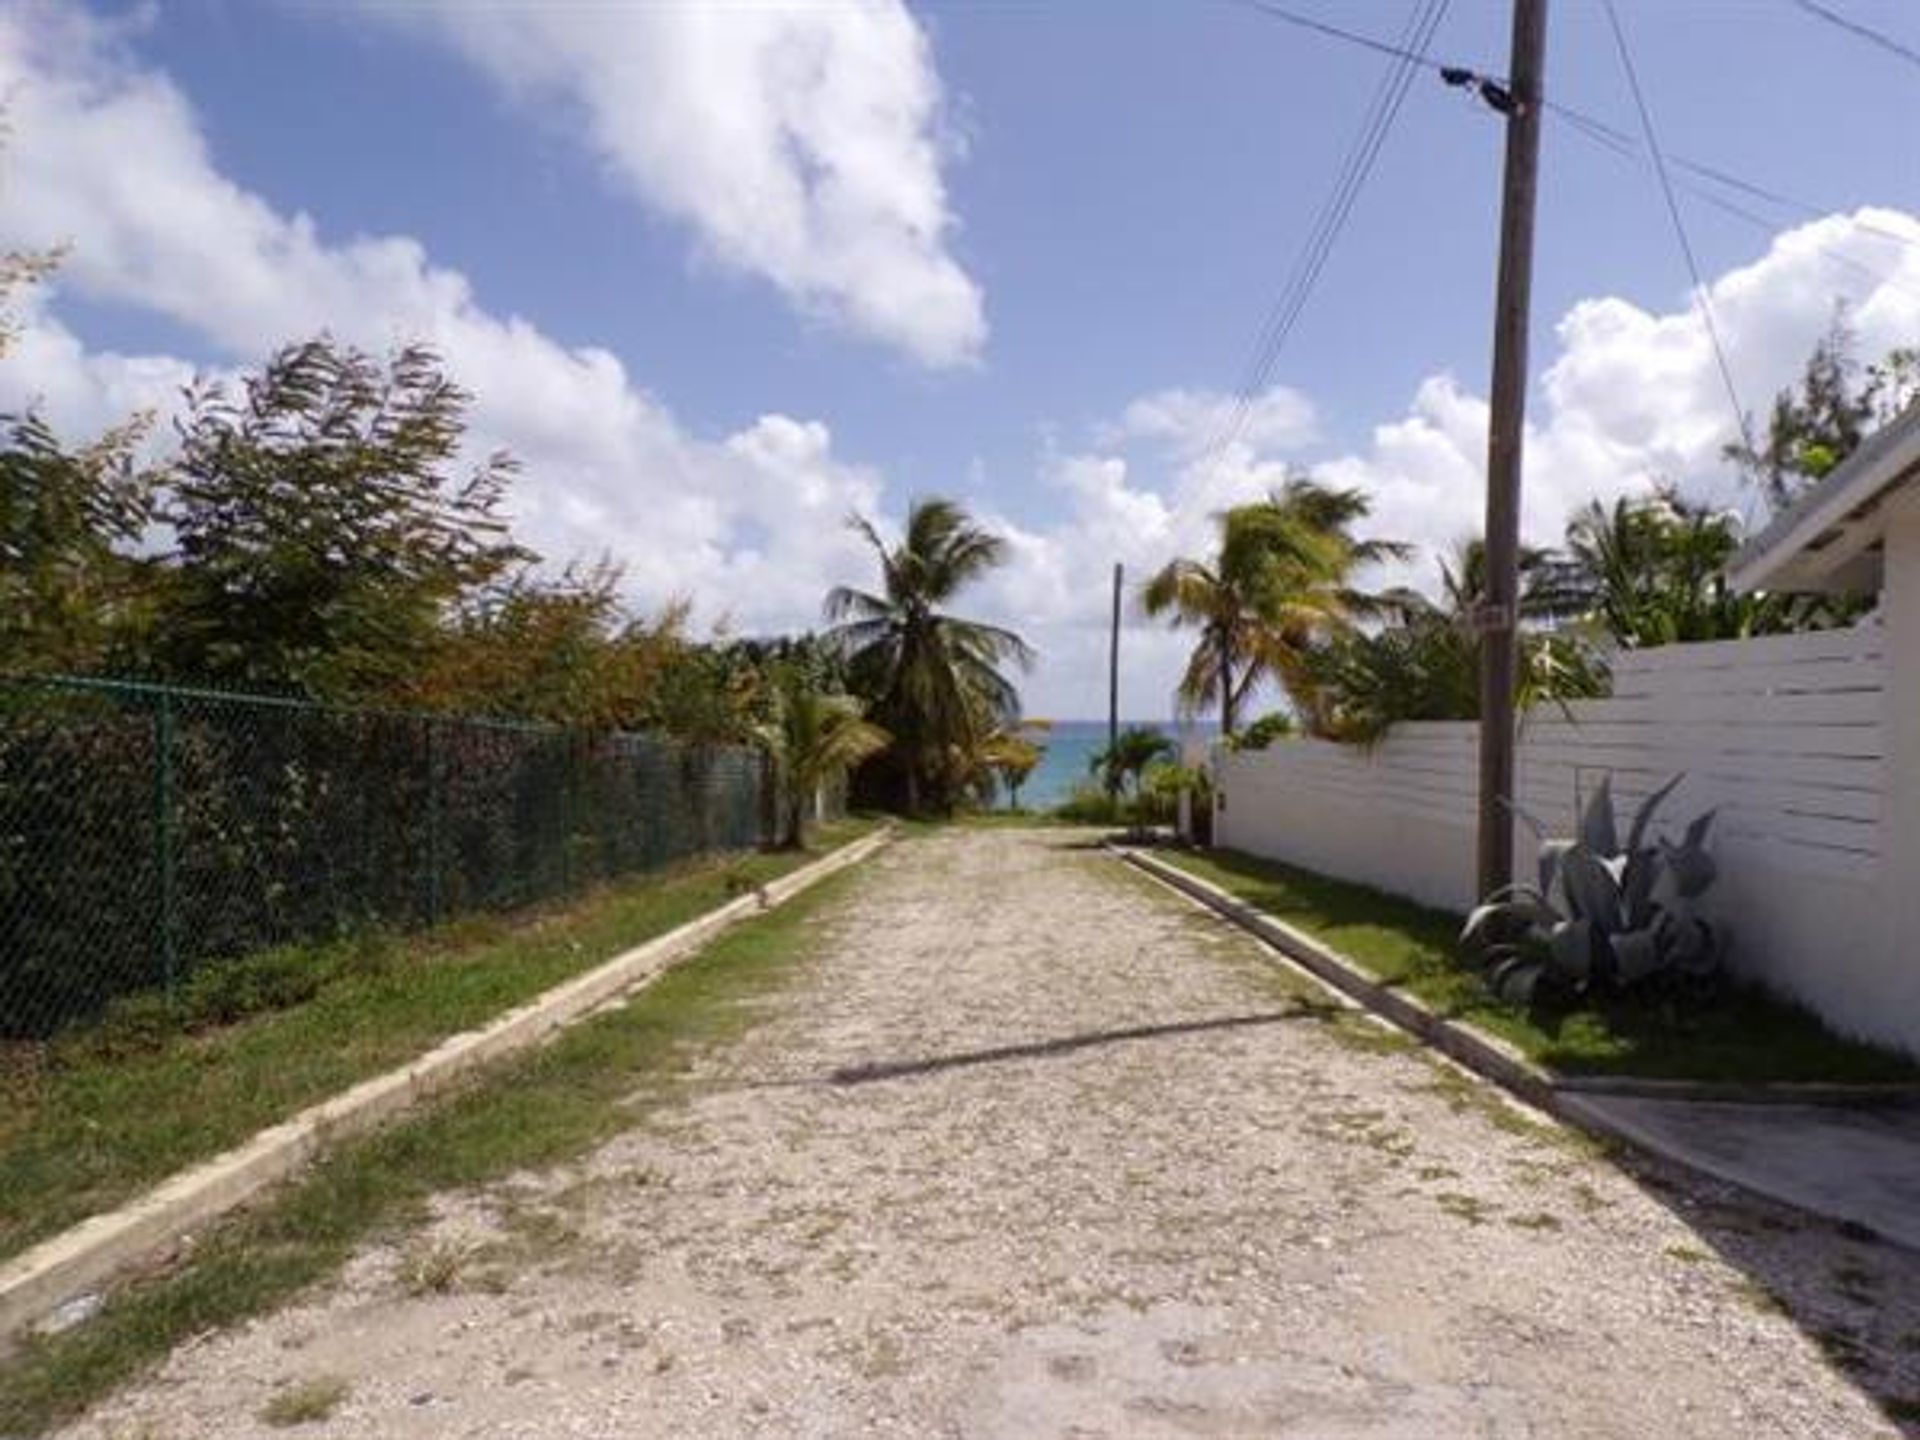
371;0;987;365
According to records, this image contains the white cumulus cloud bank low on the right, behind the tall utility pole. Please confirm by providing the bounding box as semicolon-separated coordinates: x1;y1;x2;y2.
1000;207;1920;714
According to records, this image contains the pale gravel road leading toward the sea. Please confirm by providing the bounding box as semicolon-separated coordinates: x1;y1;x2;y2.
60;829;1920;1440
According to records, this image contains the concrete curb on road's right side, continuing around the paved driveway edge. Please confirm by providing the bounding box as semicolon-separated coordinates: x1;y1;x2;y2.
1108;841;1914;1244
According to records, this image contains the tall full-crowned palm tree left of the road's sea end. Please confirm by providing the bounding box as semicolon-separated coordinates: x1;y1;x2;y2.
826;497;1033;812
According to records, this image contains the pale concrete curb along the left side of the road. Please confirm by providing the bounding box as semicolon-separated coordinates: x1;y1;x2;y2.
0;826;899;1338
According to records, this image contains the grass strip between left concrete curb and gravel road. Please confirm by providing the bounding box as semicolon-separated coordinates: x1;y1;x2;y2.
0;856;858;1434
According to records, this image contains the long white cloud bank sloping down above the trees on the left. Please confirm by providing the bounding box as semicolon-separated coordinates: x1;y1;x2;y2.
0;10;879;628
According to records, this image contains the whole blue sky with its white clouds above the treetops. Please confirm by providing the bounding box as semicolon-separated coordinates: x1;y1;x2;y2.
0;0;1920;716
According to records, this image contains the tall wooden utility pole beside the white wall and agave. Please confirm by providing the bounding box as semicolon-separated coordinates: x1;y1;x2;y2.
1476;0;1548;899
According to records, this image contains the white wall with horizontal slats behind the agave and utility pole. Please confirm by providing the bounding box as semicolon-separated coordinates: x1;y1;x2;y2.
1215;629;1920;1054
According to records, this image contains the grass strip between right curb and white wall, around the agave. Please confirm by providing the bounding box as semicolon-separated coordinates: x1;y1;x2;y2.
1162;851;1920;1083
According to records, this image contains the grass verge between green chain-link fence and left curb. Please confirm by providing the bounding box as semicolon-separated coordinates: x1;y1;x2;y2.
0;822;870;1258
